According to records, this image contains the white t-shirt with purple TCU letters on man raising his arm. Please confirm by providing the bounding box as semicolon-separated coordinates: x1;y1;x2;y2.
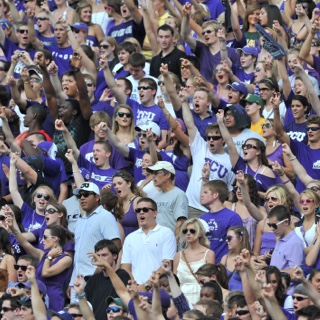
186;131;235;212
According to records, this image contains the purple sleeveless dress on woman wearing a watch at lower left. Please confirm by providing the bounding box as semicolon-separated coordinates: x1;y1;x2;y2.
36;252;72;312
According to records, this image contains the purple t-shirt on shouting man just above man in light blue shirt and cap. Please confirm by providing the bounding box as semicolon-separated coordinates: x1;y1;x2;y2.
78;154;117;189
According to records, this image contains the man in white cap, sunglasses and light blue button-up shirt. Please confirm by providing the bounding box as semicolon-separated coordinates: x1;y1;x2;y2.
70;182;121;302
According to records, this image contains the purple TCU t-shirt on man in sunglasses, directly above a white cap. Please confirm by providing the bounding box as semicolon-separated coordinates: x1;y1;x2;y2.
126;98;170;130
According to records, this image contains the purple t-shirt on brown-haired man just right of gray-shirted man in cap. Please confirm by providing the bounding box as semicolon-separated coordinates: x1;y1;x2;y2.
199;208;243;263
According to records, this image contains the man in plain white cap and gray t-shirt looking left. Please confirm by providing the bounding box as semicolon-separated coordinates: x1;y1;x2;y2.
147;161;188;237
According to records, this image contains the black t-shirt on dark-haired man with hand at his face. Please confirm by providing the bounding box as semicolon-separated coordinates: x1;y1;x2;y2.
85;269;130;320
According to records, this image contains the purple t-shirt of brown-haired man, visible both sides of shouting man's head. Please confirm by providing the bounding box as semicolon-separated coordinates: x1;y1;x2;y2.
80;140;130;170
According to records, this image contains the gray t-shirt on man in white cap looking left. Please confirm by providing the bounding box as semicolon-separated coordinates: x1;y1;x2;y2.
153;187;188;232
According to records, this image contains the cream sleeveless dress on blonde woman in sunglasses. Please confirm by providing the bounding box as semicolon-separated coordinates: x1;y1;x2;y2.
177;249;209;304
